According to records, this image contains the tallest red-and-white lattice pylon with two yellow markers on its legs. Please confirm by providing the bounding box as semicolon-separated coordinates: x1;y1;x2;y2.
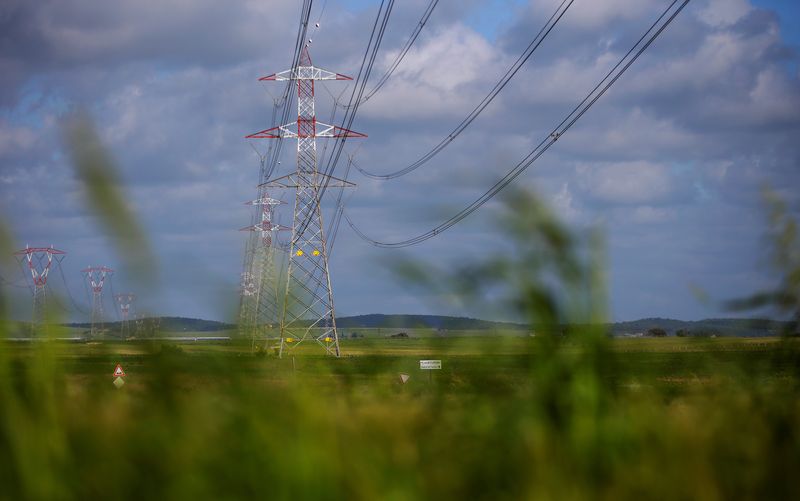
247;46;366;357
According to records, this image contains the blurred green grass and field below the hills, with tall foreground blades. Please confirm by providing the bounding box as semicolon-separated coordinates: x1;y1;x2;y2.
0;116;800;501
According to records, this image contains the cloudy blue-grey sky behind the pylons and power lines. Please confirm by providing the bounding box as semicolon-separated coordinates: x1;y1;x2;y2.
0;0;800;321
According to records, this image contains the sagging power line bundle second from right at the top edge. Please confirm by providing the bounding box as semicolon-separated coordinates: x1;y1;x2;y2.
356;0;575;180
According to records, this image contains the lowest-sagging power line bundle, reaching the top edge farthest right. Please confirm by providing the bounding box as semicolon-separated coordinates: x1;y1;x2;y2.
344;0;691;248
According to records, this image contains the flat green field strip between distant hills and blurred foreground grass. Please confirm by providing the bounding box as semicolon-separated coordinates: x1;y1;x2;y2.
5;332;800;394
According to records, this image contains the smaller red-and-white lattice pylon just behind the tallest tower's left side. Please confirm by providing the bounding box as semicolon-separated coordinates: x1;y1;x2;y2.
239;196;289;343
